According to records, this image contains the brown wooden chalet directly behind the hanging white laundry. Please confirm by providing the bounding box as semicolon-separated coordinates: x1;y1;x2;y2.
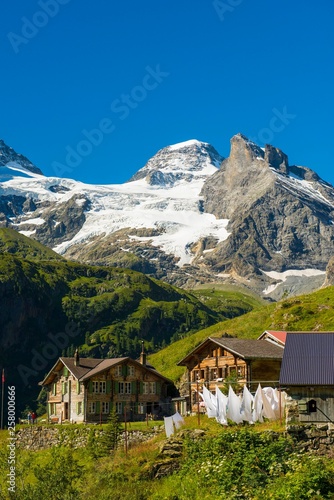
178;337;283;412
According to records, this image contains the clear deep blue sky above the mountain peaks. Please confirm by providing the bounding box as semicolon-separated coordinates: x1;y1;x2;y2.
0;0;334;184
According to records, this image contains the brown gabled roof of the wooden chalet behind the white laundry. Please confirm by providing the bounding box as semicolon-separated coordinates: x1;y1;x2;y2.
177;337;283;365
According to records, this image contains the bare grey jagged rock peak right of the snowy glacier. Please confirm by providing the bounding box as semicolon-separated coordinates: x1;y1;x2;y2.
201;134;334;278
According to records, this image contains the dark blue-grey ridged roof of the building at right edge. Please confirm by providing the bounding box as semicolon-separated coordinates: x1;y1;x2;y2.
280;332;334;386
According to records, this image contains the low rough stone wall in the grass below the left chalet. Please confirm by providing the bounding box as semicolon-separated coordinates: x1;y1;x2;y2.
16;425;162;450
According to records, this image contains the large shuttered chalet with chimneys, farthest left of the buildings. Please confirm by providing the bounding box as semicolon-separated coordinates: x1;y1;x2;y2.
40;351;172;423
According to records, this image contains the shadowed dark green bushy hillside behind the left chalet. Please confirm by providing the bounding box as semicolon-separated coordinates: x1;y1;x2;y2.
0;229;257;414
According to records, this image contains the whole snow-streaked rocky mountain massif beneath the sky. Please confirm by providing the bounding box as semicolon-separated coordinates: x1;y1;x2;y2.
0;134;334;299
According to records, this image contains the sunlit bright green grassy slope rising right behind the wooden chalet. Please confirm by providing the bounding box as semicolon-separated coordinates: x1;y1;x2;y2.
149;286;334;381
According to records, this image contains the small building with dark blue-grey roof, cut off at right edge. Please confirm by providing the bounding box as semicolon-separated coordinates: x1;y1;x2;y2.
280;332;334;423
